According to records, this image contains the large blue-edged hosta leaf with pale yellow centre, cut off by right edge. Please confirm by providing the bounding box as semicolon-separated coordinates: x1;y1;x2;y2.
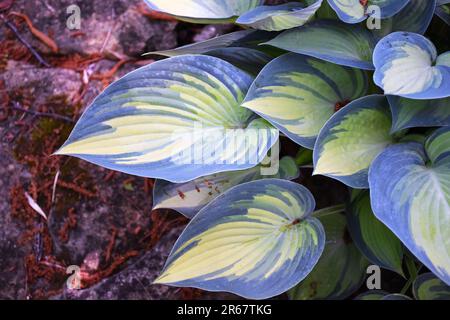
369;127;450;284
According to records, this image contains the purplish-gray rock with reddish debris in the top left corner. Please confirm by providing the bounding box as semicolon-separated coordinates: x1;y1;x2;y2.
8;0;177;57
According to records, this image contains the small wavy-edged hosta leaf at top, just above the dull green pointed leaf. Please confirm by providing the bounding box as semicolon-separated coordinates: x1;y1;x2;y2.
236;0;323;31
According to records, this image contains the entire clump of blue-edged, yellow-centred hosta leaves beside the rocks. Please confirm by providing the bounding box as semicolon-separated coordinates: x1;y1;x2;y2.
57;0;450;300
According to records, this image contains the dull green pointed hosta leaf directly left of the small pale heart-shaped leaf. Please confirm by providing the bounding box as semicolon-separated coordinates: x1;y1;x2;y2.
265;20;376;70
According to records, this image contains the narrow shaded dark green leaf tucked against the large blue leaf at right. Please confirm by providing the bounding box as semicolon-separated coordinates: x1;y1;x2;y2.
347;190;403;275
